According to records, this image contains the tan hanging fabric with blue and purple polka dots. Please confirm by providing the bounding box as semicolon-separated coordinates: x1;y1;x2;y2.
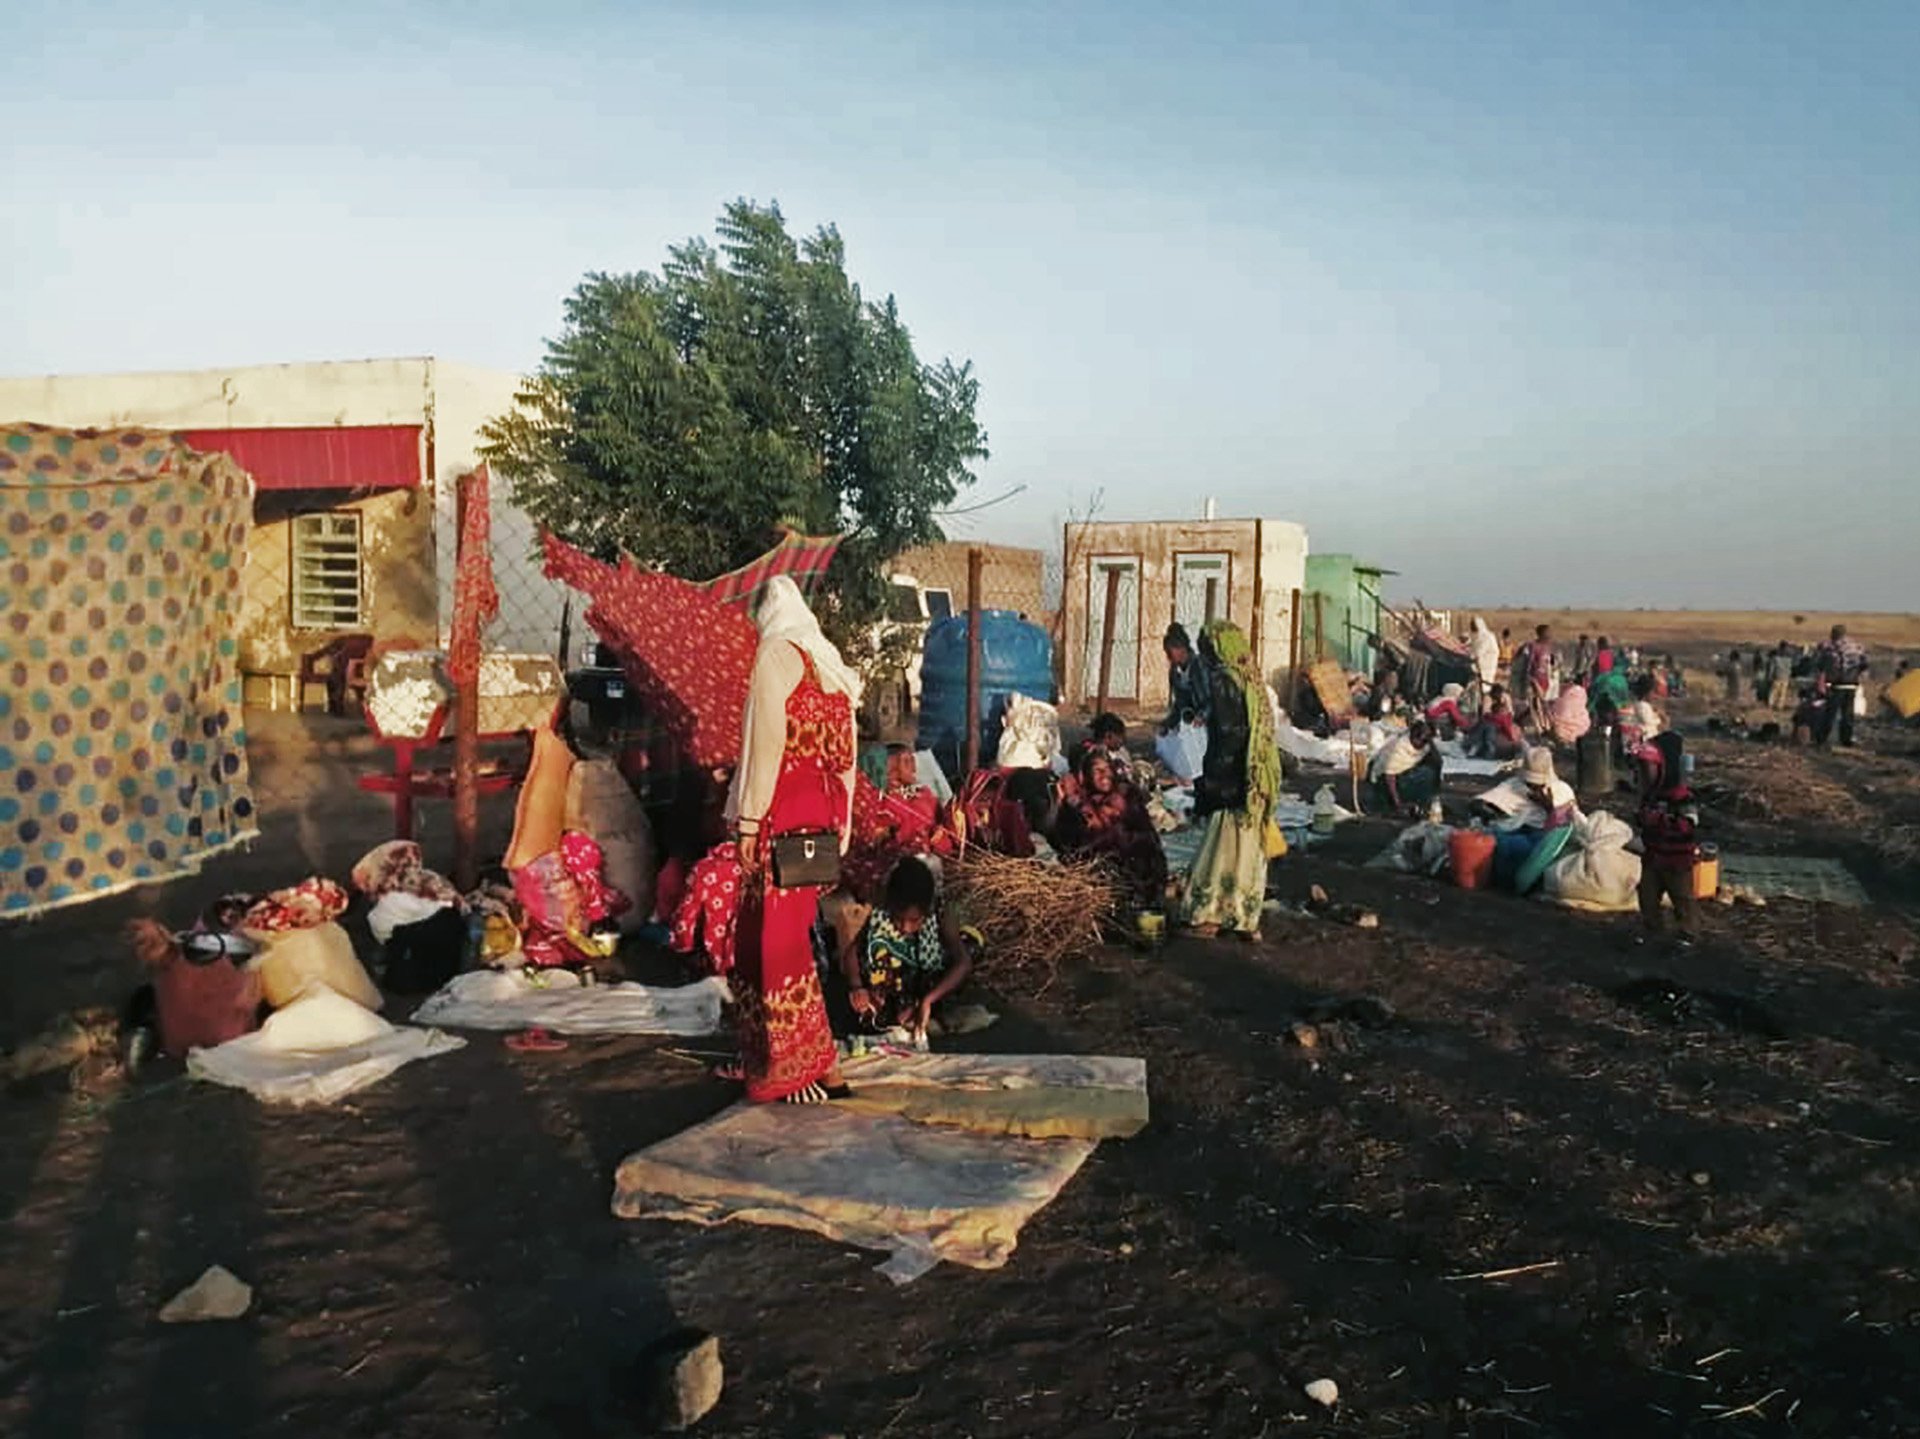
0;425;257;916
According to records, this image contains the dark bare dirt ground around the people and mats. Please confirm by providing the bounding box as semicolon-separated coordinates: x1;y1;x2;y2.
0;703;1920;1439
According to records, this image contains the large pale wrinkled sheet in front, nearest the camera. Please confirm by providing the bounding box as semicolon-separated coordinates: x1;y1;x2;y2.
612;1105;1096;1283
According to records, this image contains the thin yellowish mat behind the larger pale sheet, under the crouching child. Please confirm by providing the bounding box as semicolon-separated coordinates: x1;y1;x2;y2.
843;1055;1148;1139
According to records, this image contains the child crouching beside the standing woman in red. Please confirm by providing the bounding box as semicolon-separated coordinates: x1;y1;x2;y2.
829;859;973;1034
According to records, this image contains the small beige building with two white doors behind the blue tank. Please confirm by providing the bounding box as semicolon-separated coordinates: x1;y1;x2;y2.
1060;519;1308;711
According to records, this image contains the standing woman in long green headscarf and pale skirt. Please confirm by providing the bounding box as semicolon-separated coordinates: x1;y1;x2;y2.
1187;621;1281;938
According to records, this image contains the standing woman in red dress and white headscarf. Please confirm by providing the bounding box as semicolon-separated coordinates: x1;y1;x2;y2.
732;574;860;1103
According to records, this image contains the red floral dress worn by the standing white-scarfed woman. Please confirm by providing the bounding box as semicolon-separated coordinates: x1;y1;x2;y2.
733;651;854;1101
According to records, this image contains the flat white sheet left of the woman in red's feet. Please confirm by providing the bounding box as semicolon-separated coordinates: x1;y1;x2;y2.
413;970;728;1036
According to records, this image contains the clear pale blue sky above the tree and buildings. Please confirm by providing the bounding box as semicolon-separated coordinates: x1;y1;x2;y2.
0;0;1920;609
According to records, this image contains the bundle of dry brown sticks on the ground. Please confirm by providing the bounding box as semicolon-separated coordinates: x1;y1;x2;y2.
947;849;1121;988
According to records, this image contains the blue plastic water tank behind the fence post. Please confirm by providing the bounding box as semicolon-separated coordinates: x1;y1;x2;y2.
920;609;1060;782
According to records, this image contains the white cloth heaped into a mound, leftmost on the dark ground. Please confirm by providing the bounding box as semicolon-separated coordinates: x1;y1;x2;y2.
186;986;467;1105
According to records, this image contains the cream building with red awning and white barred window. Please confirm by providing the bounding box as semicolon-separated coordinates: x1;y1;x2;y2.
0;357;566;703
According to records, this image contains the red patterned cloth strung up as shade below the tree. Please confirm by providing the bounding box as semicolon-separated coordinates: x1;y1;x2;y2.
547;534;760;767
